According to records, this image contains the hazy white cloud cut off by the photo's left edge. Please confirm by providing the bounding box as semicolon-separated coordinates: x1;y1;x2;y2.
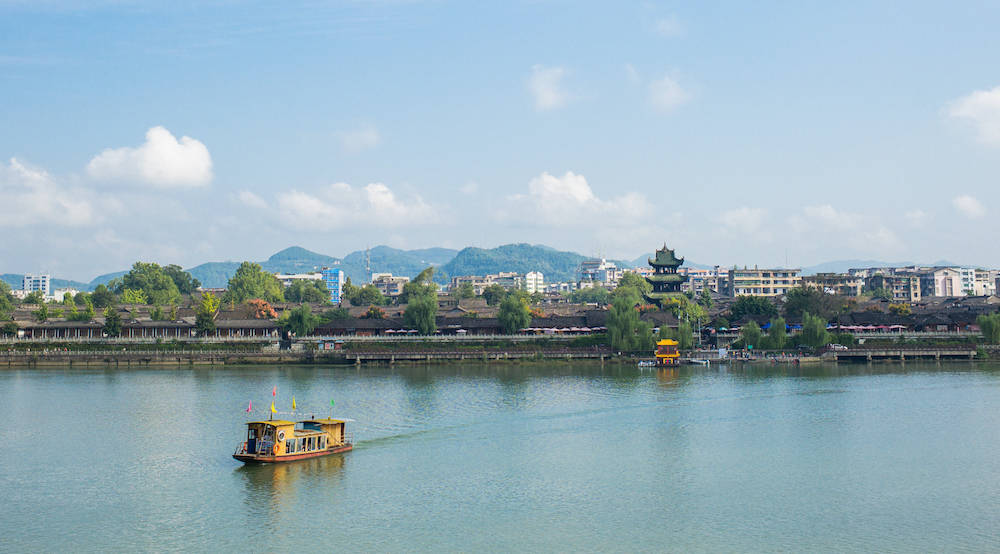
0;158;102;227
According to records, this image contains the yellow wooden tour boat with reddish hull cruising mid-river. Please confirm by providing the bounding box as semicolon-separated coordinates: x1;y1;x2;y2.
233;418;354;463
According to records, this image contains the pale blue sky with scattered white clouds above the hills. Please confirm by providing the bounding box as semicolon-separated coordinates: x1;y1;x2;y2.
0;0;1000;280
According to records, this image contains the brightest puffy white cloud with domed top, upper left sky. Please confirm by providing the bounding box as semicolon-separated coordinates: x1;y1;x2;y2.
87;126;212;188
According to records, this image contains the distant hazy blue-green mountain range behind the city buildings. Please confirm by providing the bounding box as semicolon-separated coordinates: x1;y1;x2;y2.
0;243;976;290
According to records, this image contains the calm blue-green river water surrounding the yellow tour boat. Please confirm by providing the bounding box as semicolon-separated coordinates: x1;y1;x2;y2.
0;364;1000;552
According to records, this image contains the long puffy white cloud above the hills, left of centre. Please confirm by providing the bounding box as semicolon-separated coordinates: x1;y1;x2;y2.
277;183;439;231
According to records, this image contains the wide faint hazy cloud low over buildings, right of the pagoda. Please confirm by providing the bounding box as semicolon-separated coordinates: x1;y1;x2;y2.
788;204;901;253
